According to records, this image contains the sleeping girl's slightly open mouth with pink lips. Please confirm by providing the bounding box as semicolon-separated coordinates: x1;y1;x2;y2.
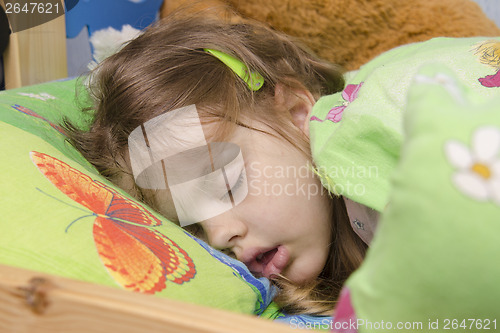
245;245;290;278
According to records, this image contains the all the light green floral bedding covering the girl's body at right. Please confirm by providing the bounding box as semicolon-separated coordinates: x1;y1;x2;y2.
311;38;500;332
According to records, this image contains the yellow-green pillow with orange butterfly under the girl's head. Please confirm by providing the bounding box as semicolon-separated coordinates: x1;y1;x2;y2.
0;79;276;317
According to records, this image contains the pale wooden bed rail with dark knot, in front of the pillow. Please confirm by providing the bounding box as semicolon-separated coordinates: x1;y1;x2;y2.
0;265;297;333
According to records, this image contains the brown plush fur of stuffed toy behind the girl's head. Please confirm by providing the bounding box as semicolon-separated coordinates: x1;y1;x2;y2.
160;0;500;70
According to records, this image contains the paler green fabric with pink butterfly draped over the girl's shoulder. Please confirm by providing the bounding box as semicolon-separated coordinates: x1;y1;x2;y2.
310;37;500;212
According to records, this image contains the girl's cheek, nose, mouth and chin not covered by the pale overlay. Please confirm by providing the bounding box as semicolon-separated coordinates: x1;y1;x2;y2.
197;122;331;283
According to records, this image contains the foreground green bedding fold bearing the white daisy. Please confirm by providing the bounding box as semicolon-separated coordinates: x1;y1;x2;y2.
333;64;500;332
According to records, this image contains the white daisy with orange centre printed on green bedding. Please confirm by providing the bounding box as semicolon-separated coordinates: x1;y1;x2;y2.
444;126;500;205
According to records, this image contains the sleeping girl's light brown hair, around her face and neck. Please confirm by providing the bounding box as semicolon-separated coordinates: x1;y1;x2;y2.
66;12;364;314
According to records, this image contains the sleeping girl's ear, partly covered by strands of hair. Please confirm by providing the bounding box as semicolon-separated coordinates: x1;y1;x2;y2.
274;83;316;137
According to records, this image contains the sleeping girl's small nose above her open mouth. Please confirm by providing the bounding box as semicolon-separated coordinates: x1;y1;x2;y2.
202;214;248;249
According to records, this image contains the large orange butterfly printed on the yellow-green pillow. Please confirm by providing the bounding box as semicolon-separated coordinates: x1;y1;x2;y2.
31;151;196;294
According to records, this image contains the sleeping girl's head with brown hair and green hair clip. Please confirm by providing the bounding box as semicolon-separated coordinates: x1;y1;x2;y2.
67;8;500;314
